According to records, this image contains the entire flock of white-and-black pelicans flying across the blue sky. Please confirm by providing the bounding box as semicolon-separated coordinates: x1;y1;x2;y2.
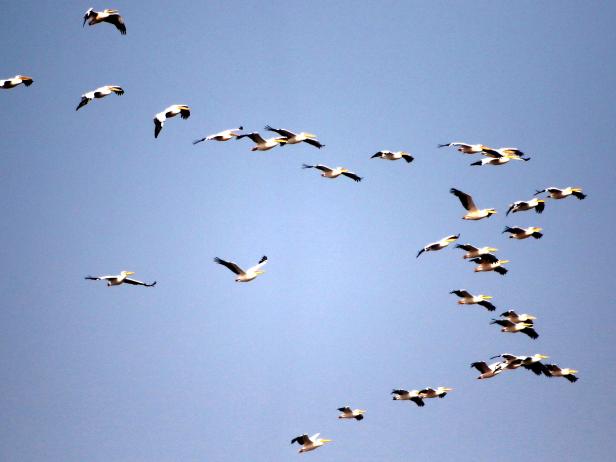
0;8;586;453
